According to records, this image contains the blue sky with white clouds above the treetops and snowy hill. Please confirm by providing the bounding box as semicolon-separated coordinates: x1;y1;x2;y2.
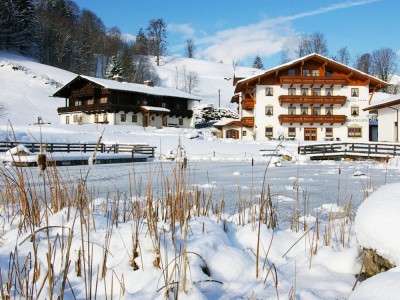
75;0;400;69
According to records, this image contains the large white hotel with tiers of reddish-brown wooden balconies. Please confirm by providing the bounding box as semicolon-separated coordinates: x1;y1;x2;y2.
220;53;389;141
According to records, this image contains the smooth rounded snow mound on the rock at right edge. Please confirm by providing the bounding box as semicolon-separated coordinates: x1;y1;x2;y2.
355;183;400;265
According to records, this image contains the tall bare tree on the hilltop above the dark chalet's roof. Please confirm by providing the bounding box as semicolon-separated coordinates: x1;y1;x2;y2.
146;19;167;66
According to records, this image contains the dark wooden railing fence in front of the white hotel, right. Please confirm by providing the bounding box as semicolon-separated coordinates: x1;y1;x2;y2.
298;143;400;159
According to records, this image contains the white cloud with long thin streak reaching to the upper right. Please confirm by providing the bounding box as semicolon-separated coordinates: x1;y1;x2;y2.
196;0;380;61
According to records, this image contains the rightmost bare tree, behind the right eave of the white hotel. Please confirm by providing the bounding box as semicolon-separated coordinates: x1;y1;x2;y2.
371;48;397;82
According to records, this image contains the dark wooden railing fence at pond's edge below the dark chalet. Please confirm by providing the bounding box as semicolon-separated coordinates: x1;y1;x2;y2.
0;141;156;158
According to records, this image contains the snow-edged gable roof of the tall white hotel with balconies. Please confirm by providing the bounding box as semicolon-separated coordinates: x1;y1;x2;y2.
235;53;389;92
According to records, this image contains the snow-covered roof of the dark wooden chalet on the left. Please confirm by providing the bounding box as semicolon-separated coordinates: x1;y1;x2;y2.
54;75;201;101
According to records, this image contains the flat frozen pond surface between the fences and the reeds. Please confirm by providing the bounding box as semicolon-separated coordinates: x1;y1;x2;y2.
55;161;400;223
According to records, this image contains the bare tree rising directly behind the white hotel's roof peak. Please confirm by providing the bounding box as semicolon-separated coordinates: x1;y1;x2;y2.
296;32;328;57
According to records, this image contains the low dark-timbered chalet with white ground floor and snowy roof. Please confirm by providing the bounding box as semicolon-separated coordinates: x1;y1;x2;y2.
53;75;200;127
